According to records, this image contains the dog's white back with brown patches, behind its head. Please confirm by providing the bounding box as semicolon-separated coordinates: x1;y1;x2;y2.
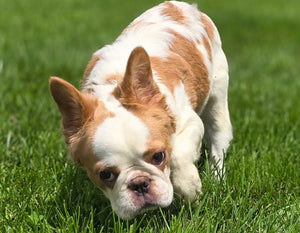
82;1;221;112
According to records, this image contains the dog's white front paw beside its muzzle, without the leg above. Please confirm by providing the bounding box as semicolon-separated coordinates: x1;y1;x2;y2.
172;164;202;201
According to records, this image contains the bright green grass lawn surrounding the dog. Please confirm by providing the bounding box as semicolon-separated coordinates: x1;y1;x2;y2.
0;0;300;232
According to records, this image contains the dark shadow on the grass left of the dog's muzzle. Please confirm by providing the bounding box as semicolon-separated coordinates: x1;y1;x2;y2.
48;162;113;232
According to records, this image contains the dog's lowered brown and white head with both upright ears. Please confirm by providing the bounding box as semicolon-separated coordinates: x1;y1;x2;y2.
50;48;175;218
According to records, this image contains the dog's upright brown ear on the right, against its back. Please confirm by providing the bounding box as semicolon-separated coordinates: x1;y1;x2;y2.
120;47;163;104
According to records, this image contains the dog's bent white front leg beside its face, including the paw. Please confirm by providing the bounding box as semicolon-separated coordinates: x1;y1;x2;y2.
171;111;204;201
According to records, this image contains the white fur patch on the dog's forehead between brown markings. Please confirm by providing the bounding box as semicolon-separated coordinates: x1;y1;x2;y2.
93;101;149;167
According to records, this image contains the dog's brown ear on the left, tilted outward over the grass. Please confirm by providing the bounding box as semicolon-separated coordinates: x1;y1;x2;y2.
49;77;98;144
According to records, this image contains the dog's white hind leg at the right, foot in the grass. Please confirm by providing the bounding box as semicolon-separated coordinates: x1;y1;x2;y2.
201;48;232;178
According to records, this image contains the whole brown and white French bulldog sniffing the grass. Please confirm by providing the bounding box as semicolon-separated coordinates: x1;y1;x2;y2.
49;1;232;219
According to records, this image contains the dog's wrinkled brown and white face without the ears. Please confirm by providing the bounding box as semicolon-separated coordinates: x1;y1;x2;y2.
81;104;173;218
